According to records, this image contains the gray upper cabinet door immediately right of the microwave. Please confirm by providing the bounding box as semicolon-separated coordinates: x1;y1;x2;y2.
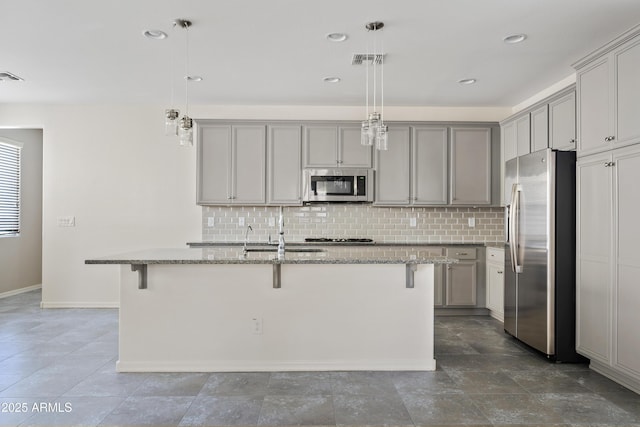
374;126;411;206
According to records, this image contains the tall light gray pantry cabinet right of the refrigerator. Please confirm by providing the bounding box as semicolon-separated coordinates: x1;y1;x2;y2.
574;25;640;393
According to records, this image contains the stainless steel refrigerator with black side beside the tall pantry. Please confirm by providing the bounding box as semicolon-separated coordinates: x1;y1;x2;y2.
504;149;584;362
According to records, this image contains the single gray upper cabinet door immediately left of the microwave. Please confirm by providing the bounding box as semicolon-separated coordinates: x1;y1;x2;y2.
267;125;302;206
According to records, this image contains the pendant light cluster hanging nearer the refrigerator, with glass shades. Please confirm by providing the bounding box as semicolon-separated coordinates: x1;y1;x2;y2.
360;21;389;150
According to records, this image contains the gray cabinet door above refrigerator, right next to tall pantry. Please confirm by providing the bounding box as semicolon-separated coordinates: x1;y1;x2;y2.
549;91;576;151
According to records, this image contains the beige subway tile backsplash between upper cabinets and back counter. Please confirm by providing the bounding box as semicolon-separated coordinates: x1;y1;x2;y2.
202;204;504;243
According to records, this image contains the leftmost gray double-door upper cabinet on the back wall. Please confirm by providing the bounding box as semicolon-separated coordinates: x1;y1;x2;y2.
196;124;266;205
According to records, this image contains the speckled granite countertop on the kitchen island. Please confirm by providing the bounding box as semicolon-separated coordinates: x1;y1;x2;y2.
85;245;457;264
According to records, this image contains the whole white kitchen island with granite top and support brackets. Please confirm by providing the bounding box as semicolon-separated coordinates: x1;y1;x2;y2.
86;246;455;372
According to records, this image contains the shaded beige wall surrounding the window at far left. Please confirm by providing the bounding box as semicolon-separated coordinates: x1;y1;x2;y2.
0;129;42;296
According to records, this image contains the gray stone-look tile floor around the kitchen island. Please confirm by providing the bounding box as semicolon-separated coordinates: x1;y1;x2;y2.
0;291;640;426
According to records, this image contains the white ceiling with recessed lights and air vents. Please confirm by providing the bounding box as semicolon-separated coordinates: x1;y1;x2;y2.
0;0;640;106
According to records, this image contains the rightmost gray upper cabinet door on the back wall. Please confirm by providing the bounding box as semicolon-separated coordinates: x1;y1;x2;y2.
449;127;491;205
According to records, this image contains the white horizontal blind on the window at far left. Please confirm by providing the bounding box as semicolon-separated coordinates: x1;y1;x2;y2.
0;141;21;236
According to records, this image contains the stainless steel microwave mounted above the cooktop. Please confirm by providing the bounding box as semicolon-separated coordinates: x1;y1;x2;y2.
302;168;373;202
